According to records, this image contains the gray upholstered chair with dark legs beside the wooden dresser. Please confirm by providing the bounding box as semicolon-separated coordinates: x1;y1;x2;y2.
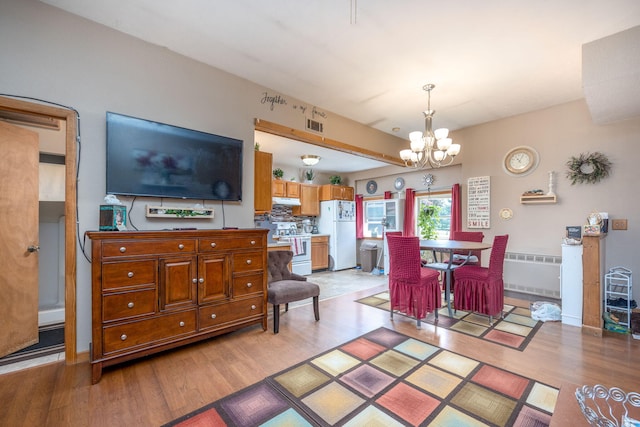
267;251;320;334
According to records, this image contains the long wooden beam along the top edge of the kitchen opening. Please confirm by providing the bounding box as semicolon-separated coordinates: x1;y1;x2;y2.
255;119;404;170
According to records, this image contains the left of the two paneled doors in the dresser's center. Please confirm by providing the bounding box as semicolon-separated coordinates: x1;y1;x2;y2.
158;257;197;311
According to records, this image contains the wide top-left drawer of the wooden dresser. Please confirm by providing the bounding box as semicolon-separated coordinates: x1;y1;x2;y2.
102;239;196;258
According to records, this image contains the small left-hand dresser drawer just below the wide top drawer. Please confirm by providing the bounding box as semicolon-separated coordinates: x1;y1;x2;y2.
102;259;158;291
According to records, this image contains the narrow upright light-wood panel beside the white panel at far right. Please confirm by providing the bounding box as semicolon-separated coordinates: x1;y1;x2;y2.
582;236;604;336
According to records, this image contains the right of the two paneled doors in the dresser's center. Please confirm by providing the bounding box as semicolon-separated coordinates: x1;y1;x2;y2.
198;253;231;304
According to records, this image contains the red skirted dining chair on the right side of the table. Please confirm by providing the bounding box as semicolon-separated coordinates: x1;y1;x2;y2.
453;234;509;324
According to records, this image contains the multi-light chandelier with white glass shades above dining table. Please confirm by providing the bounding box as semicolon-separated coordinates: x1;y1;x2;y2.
400;84;460;168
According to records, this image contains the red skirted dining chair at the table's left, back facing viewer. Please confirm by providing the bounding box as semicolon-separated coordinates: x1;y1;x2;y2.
387;235;442;327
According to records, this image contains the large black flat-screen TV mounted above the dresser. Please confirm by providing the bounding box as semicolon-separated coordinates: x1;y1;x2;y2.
107;112;242;201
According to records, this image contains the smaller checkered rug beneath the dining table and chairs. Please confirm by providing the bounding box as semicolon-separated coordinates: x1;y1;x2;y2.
356;291;543;351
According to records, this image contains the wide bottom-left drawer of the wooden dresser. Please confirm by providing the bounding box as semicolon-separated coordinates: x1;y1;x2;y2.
102;309;196;354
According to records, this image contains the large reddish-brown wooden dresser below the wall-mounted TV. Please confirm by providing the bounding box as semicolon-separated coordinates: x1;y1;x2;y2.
87;229;267;384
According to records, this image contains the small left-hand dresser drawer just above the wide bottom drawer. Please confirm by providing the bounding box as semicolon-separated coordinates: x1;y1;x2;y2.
102;289;158;322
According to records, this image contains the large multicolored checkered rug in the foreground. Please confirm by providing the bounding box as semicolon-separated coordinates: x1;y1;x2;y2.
166;328;558;427
